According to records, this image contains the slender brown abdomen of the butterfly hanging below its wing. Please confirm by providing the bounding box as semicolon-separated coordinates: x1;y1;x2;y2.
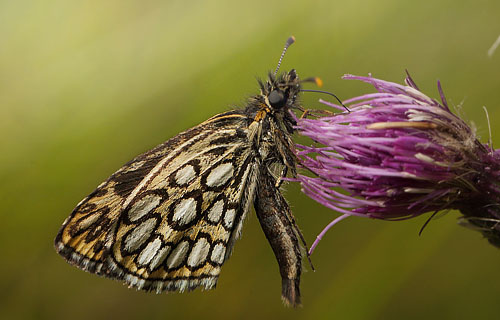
255;172;302;307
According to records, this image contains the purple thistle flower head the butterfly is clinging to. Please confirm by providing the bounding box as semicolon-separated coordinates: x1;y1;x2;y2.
296;75;500;253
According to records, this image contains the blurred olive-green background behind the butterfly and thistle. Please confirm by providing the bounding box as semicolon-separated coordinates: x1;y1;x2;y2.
0;0;500;319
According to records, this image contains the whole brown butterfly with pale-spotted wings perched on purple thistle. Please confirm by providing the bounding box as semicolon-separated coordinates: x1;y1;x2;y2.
55;37;320;306
